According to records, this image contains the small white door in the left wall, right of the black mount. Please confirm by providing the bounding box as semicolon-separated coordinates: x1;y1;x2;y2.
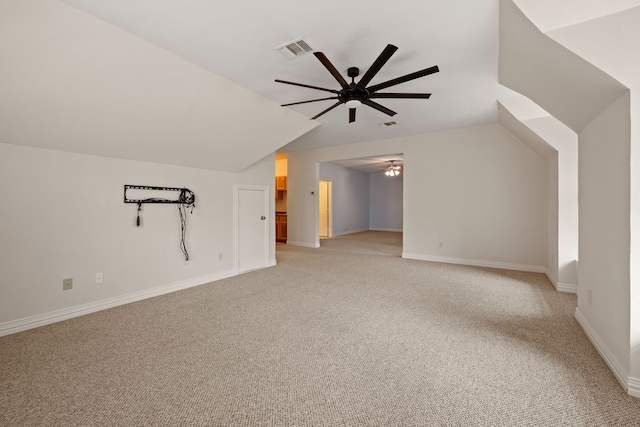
236;187;270;273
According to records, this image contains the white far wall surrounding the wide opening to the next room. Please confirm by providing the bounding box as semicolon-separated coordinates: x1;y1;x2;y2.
288;124;547;271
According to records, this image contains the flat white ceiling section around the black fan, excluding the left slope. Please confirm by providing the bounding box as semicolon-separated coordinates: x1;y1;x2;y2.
53;0;507;150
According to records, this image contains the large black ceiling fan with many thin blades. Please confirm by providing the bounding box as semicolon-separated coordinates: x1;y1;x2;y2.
276;44;440;123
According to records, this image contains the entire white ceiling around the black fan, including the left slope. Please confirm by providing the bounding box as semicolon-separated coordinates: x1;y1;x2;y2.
0;0;510;171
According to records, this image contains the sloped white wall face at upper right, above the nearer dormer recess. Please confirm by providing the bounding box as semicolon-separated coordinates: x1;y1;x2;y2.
498;0;628;132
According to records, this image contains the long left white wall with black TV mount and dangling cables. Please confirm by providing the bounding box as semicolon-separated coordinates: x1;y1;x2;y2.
0;144;275;333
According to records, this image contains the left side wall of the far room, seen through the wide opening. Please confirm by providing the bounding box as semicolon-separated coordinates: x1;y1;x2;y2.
319;163;369;236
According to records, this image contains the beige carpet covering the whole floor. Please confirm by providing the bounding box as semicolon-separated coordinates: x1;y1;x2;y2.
0;232;640;426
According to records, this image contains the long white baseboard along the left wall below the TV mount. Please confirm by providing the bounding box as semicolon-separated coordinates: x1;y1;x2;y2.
0;270;236;337
